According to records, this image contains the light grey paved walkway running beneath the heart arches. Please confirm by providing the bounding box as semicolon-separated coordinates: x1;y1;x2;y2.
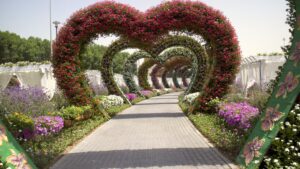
52;93;237;169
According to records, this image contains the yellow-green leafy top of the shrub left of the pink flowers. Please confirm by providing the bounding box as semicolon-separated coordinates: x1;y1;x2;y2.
6;112;34;132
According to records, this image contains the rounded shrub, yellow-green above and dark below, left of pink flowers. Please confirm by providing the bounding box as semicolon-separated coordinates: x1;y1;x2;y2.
6;112;34;140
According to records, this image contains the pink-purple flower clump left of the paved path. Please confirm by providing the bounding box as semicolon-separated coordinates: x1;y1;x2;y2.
34;116;64;136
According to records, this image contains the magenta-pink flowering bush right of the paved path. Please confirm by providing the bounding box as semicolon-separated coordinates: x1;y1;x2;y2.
219;102;259;132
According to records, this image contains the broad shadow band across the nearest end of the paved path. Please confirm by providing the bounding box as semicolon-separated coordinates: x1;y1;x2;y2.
54;148;226;169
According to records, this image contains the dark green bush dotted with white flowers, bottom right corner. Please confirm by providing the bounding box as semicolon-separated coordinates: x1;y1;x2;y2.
260;104;300;169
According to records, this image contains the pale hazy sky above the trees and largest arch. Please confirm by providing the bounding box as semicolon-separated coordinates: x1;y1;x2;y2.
0;0;290;57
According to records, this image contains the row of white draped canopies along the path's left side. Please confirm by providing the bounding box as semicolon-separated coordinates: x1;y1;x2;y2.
0;63;188;98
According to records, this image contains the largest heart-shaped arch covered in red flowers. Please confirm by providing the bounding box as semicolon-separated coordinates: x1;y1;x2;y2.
52;1;240;111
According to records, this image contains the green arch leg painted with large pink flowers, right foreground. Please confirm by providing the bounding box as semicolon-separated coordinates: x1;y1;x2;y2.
237;1;300;169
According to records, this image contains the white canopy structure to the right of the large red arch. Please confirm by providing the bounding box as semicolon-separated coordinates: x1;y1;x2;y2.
236;56;286;91
